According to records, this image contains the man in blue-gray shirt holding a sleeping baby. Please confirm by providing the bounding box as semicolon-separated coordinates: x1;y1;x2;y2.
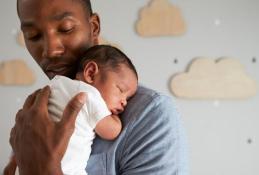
7;0;187;175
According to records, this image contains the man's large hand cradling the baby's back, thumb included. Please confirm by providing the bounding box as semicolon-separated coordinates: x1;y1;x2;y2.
10;86;86;175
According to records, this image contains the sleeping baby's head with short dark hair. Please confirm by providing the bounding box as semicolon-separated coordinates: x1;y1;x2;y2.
76;45;138;115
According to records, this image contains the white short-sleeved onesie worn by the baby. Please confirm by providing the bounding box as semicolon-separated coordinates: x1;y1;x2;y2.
48;76;111;175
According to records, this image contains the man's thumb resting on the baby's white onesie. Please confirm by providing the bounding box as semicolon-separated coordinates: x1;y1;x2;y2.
60;92;87;134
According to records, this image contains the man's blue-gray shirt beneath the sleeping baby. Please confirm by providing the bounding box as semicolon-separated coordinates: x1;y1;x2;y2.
86;86;188;175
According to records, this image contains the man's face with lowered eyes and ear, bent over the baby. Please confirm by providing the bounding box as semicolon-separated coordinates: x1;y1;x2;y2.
18;0;100;79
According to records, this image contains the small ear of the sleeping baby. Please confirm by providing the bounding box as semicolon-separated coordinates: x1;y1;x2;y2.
83;61;99;84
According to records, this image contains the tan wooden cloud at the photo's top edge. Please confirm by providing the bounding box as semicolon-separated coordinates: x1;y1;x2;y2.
136;0;186;37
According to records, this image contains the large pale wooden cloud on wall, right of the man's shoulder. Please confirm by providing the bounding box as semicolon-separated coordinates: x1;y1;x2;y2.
171;57;257;100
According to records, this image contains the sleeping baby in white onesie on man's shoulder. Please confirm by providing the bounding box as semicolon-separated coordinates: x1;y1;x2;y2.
49;45;138;175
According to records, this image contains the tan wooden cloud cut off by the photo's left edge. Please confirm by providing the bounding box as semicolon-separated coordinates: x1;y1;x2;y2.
0;59;36;86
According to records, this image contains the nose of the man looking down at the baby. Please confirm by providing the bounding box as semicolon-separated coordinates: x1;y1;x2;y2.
42;35;65;58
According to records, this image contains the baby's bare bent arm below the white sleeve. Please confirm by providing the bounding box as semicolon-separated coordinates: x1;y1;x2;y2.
95;115;122;140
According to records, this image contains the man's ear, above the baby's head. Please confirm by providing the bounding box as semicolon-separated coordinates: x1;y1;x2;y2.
90;13;101;45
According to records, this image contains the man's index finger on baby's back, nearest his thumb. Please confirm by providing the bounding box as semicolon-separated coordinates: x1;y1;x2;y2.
34;86;50;110
